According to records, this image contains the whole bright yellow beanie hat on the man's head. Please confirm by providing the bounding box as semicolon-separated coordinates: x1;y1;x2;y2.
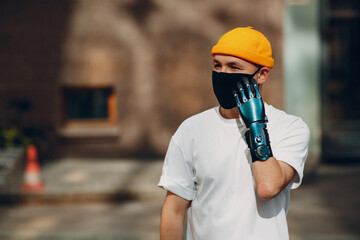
211;27;274;68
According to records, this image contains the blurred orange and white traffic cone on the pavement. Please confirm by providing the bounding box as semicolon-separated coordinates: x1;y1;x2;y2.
21;145;44;193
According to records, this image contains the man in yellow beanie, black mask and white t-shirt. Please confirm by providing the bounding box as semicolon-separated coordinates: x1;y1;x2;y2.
159;27;309;240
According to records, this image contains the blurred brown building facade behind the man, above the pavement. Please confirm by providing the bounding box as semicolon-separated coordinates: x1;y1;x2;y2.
0;0;360;166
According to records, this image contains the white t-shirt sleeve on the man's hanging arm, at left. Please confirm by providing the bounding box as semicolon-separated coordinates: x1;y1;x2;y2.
158;137;196;201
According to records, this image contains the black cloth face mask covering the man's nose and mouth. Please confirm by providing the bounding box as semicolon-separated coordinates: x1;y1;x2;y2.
212;68;260;109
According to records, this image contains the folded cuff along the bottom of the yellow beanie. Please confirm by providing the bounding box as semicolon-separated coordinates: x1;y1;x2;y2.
211;45;274;68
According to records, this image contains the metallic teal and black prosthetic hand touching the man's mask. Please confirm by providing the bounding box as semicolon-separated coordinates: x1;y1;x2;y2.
233;78;272;162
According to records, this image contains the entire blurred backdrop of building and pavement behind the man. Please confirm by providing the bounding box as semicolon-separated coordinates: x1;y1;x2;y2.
0;0;360;239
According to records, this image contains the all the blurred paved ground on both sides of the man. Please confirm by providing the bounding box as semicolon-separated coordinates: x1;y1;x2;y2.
0;159;360;240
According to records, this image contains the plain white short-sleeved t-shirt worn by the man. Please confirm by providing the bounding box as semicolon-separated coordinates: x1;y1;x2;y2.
159;104;309;240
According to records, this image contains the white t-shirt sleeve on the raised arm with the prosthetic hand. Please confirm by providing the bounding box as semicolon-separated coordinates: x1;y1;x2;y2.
270;119;310;189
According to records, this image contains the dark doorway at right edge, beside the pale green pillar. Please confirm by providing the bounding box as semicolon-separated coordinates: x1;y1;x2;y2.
321;0;360;161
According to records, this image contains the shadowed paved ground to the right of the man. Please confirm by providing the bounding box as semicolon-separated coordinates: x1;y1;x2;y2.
288;165;360;240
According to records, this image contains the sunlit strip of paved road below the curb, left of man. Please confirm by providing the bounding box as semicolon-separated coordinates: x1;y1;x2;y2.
0;201;161;240
